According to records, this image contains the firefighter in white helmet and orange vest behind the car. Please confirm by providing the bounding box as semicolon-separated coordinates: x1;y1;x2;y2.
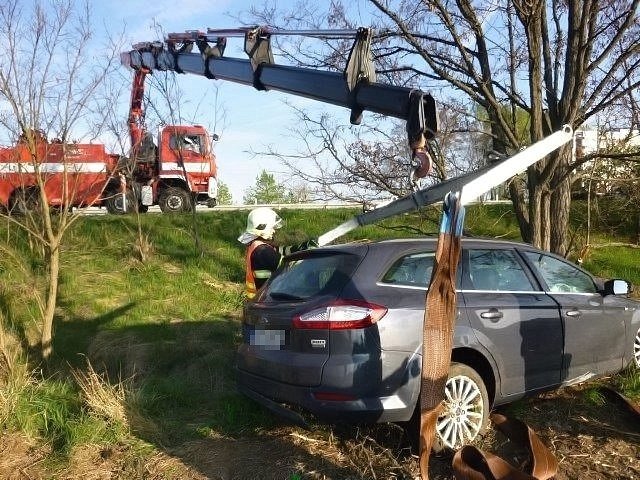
238;207;318;299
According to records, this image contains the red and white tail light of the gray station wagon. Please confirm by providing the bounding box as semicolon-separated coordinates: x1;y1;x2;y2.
293;300;387;330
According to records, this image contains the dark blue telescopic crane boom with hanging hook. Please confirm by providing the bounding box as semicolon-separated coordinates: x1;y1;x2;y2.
121;27;438;176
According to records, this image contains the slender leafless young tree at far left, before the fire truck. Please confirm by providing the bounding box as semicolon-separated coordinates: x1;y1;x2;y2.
0;0;118;359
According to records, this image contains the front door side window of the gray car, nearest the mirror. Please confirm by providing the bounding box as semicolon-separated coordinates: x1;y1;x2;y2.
525;252;597;293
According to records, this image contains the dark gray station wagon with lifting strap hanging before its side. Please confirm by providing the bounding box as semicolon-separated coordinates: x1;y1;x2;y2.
237;238;640;448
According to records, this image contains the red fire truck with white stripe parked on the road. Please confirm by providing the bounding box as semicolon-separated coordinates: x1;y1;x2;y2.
0;69;218;214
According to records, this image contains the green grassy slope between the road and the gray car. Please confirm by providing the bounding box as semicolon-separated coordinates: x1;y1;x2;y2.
0;205;640;464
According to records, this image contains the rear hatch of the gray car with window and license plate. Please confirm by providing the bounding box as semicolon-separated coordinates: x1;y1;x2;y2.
237;247;366;387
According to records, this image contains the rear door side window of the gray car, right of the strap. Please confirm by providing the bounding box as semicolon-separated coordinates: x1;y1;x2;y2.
469;249;534;292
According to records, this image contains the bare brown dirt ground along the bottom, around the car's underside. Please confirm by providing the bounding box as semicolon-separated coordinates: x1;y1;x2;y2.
0;387;640;480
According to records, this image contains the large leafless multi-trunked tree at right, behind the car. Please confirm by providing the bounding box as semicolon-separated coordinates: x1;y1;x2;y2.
244;0;640;254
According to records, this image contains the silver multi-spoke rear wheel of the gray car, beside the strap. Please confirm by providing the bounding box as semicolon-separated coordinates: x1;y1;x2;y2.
436;364;489;450
